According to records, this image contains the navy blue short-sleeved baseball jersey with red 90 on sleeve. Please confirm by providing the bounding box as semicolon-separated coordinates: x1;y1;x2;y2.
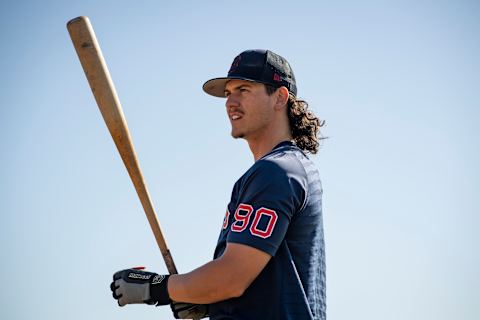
210;142;326;320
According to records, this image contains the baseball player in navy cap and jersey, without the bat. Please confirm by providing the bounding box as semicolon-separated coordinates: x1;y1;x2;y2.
111;50;326;320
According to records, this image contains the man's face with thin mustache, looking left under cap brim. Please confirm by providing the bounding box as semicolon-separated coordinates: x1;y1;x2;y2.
225;80;276;140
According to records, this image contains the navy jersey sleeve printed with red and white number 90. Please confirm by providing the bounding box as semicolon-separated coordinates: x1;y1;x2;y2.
227;160;306;256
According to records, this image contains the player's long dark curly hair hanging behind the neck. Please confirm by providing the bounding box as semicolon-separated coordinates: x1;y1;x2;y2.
265;85;325;154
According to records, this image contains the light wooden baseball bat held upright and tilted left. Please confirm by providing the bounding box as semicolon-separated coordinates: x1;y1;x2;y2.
67;16;177;274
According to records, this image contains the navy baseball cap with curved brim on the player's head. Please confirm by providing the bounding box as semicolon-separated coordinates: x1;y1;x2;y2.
203;50;297;98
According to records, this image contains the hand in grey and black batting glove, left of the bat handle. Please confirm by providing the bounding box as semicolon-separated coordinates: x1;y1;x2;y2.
110;269;172;307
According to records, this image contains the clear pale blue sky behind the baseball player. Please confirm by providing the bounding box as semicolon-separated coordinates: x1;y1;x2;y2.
0;0;480;320
